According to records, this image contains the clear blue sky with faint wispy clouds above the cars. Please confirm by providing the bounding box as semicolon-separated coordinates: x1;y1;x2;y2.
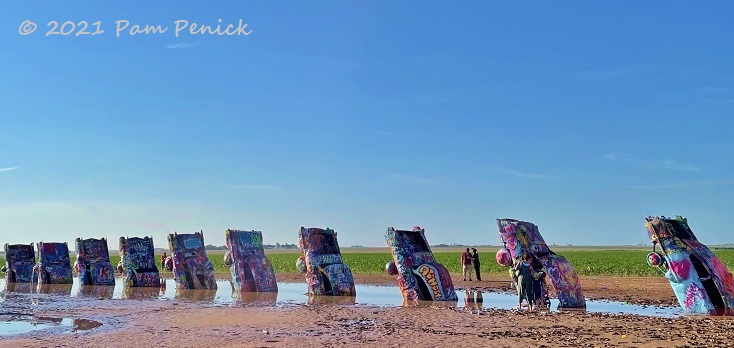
0;1;734;248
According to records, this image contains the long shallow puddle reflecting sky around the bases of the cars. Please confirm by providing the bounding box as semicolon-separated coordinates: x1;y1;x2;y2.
0;278;684;317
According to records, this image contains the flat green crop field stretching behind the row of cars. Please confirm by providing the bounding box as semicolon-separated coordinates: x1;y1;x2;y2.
0;248;734;276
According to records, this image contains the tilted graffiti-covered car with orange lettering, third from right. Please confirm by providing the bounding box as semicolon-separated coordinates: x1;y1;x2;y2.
385;226;458;301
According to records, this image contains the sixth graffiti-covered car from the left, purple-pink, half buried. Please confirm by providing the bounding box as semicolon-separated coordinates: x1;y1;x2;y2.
224;229;278;292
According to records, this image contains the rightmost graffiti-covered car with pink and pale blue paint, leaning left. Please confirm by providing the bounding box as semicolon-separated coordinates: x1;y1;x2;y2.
645;216;734;315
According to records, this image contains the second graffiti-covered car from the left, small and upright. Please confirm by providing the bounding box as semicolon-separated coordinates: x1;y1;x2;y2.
35;242;74;286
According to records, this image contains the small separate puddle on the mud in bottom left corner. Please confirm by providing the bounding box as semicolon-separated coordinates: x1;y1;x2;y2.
0;315;102;336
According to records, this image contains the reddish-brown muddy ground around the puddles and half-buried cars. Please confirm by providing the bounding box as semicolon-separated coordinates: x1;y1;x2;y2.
0;274;734;347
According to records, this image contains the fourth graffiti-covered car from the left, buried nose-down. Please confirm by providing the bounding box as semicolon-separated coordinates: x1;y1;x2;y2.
120;237;161;287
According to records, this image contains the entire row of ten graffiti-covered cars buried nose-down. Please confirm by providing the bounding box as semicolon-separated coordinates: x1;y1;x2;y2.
3;216;734;315
